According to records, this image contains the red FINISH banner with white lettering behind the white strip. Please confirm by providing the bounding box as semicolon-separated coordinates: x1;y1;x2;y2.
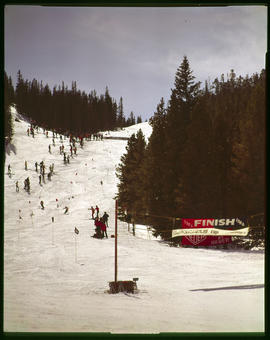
181;218;232;246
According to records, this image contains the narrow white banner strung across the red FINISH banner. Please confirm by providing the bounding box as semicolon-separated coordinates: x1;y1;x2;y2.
172;227;249;237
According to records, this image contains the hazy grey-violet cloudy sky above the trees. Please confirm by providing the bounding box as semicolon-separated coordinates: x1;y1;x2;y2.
4;5;267;120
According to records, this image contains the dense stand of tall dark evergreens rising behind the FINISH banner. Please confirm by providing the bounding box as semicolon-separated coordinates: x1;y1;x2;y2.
116;56;266;239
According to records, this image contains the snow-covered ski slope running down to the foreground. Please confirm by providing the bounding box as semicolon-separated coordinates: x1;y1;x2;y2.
4;109;264;333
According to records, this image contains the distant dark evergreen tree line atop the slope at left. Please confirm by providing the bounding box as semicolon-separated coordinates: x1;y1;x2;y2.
5;71;142;136
